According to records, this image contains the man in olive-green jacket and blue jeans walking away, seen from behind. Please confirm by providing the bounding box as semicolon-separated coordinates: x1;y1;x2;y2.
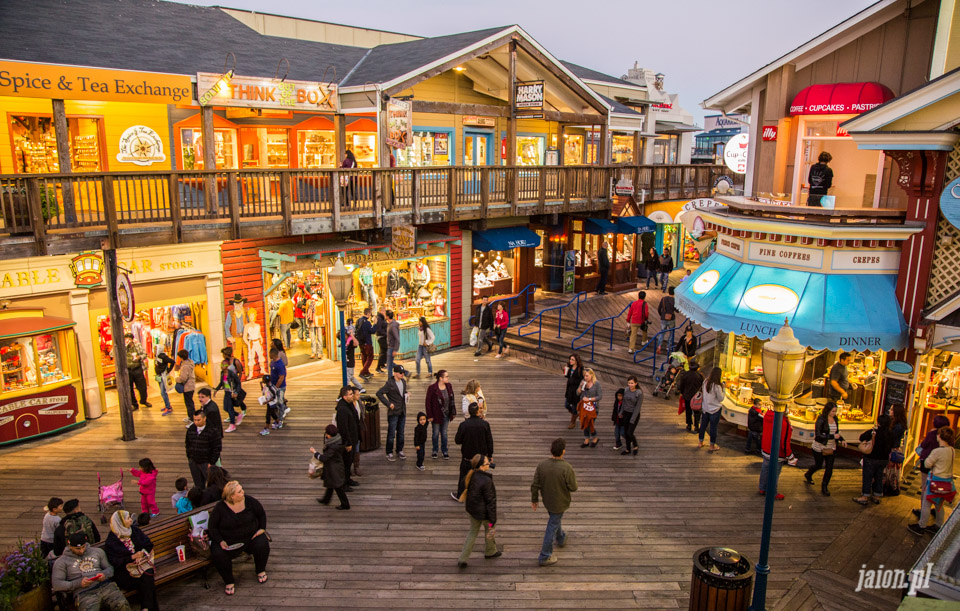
530;438;577;566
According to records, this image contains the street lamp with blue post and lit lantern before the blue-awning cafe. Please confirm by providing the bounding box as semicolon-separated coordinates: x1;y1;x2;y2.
750;321;806;611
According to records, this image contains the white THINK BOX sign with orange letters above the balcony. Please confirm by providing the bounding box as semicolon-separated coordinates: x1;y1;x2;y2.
197;72;339;112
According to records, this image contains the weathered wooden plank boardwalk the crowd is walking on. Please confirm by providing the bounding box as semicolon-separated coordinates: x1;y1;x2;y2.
0;349;926;610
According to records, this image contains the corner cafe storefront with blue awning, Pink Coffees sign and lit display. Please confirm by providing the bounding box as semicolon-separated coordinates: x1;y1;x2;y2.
677;227;908;443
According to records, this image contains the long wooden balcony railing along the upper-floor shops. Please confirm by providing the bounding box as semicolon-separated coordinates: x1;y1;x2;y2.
0;165;740;258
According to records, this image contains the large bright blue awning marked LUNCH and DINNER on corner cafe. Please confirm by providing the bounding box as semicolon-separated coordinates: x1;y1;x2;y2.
676;253;908;352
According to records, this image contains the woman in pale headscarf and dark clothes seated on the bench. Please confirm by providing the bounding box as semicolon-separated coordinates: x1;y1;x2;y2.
103;509;160;611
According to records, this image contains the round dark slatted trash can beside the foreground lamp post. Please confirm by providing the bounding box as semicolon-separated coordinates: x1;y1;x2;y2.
690;547;753;611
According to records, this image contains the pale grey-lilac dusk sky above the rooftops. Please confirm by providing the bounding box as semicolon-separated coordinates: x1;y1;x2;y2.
176;0;875;125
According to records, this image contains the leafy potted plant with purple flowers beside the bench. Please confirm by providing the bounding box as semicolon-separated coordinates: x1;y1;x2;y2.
0;539;53;611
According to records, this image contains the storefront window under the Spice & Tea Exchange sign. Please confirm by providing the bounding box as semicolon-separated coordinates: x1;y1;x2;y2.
10;115;102;174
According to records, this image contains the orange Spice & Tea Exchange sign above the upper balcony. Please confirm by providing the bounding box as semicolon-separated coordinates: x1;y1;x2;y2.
0;61;193;104
